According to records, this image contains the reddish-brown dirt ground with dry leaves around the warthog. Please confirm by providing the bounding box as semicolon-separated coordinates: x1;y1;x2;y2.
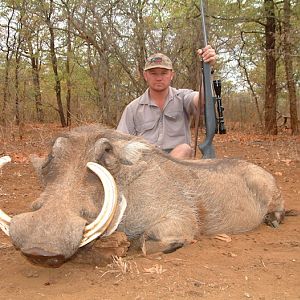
0;125;300;300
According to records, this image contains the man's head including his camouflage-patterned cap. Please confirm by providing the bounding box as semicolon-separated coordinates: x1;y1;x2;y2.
144;53;174;92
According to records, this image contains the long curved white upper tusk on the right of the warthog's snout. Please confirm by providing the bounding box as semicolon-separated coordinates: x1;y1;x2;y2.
80;162;118;247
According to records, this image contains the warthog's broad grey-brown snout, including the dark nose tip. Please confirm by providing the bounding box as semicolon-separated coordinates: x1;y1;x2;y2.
9;210;86;267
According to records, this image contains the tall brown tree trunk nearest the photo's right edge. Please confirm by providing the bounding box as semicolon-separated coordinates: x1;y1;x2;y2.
283;0;299;134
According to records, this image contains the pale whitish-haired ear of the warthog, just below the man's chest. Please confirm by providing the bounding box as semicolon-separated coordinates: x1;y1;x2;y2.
120;141;151;165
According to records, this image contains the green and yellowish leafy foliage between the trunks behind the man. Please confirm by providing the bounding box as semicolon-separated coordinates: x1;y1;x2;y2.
0;0;300;125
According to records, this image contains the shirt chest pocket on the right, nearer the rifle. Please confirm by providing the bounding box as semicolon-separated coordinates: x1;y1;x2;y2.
165;110;185;137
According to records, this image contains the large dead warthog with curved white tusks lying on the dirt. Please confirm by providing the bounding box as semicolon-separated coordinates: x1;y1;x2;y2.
0;126;284;265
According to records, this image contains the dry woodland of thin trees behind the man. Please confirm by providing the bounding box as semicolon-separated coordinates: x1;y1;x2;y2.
0;0;300;134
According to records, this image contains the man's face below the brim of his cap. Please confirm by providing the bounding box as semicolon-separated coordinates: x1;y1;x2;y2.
144;68;174;92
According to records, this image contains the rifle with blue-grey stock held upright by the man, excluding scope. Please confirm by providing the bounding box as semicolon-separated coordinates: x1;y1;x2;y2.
195;0;216;158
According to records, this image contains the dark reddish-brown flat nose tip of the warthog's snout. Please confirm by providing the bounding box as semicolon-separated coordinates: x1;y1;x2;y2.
21;247;66;268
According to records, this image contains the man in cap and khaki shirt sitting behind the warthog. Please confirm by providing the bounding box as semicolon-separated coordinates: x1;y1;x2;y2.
117;45;216;159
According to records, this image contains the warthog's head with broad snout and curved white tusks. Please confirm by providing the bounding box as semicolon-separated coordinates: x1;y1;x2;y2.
0;126;137;266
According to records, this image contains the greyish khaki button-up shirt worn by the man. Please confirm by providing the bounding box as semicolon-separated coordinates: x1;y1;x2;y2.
117;87;197;150
